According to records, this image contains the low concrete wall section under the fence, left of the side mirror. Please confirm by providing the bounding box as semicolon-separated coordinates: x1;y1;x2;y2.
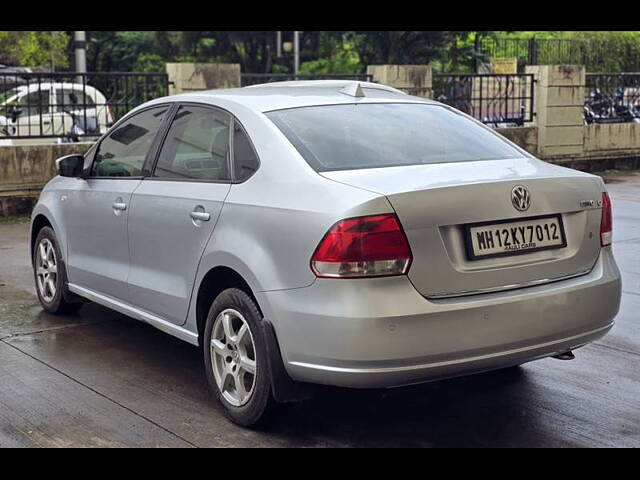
0;143;92;216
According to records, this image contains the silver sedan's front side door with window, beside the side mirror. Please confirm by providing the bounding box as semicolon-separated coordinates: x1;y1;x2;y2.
64;106;169;301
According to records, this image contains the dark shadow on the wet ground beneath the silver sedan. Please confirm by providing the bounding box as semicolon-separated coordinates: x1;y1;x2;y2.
54;305;548;447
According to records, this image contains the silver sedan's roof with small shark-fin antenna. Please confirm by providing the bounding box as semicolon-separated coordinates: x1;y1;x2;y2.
153;80;438;112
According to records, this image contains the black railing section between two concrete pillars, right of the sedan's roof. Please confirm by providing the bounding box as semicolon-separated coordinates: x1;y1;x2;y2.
433;74;534;127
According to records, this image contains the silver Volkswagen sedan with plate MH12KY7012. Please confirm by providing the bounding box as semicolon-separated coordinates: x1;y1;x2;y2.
31;81;621;425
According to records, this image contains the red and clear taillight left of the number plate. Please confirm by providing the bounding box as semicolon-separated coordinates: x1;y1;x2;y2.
311;215;411;278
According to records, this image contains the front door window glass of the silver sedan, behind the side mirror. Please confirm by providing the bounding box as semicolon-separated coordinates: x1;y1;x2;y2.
91;106;169;177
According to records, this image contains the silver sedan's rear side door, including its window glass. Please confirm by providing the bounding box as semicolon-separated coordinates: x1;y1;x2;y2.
128;104;232;325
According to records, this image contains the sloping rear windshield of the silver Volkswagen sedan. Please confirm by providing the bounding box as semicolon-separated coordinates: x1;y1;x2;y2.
266;103;523;172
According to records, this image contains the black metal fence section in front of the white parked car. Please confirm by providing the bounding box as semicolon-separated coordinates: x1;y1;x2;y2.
0;72;169;141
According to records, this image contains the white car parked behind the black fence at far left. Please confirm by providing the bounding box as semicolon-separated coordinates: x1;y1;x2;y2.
0;82;114;143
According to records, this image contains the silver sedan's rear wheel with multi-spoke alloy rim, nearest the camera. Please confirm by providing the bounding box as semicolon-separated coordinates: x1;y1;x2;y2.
202;288;275;427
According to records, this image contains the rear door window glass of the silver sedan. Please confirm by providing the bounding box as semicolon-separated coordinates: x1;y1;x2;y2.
153;105;230;181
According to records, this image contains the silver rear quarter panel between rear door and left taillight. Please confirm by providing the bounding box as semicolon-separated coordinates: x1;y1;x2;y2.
182;111;393;331
